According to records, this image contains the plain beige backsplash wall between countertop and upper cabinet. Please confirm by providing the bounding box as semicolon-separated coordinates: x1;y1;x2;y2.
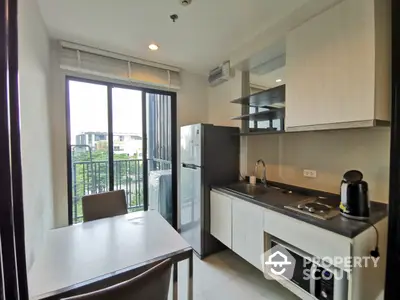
247;128;390;203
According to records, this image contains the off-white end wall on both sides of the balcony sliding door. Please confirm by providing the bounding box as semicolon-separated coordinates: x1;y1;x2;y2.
50;48;208;227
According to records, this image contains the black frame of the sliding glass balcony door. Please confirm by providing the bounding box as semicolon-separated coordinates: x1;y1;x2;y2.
65;75;178;229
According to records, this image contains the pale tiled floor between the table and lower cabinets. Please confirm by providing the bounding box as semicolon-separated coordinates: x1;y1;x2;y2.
170;250;298;300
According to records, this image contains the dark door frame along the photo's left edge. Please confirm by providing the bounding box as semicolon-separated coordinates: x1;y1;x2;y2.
0;1;29;300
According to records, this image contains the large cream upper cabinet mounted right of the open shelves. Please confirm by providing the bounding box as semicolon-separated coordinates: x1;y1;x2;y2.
285;0;391;131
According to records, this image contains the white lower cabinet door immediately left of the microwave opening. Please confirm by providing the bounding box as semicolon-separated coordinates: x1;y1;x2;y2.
232;199;264;271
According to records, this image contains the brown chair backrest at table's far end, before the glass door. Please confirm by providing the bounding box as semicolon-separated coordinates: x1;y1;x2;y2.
82;190;128;222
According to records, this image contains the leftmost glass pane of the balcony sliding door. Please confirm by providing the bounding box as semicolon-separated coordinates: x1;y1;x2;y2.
68;80;109;223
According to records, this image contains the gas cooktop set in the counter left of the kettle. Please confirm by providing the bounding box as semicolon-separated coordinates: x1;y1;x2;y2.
285;197;340;220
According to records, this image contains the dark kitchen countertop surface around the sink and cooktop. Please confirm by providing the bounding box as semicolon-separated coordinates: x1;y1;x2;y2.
212;182;387;238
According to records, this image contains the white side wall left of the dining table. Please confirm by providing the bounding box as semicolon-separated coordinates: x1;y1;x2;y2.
18;0;53;269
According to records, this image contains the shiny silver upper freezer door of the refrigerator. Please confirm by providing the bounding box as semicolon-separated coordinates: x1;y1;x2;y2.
181;124;202;166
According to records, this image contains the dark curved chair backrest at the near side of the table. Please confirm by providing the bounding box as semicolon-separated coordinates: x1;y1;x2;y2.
62;259;172;300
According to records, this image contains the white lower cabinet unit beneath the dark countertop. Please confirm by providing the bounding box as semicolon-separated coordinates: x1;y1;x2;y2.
210;190;387;300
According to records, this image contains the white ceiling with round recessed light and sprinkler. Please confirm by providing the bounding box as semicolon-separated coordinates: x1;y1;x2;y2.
38;0;308;73
